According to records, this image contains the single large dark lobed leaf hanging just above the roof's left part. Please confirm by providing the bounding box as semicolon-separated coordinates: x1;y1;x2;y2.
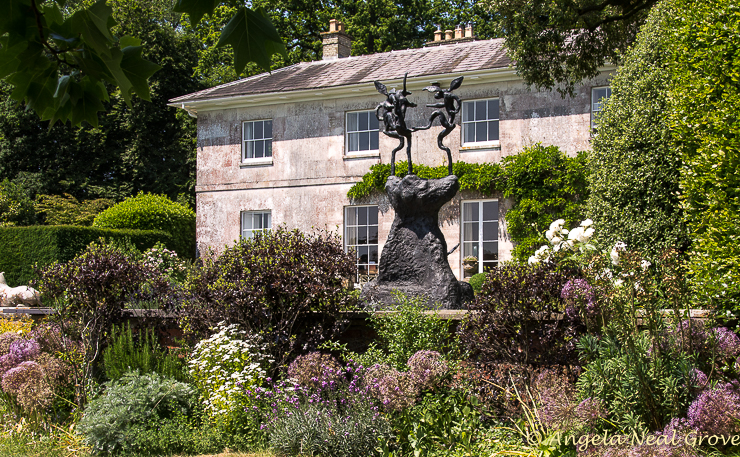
216;7;288;74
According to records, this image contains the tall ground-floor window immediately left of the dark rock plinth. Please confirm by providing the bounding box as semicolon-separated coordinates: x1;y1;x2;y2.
344;206;379;283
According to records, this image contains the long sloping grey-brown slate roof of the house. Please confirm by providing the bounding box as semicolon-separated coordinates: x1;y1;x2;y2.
170;38;511;103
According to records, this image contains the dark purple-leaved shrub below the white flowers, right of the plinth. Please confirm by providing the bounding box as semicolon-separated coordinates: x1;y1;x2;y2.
459;263;585;365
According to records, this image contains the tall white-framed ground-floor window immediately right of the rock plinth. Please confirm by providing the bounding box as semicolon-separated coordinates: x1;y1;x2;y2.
461;200;498;278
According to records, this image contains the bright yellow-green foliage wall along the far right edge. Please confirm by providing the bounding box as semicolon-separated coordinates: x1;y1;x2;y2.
668;0;740;316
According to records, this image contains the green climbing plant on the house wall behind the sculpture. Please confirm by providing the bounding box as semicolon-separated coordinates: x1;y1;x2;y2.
347;143;588;262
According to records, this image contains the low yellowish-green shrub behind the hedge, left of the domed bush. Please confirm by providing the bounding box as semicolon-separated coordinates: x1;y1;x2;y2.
35;194;114;227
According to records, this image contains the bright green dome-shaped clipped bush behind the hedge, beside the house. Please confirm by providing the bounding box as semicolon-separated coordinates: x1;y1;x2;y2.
93;193;195;259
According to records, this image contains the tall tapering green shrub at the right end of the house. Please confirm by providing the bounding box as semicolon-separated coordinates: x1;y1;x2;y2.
587;3;688;256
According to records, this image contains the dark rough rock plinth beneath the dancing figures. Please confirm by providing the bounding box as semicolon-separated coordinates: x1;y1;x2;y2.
362;175;473;309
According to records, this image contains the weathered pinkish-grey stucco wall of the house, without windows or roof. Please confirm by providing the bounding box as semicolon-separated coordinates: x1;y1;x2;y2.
196;71;609;277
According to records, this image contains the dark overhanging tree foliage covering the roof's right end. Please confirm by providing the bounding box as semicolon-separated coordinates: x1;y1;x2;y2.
487;0;657;94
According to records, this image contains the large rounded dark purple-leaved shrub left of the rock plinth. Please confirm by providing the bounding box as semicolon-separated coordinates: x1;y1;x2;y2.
181;227;362;366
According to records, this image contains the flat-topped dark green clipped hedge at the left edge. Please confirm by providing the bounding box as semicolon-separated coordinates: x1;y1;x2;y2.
0;225;173;286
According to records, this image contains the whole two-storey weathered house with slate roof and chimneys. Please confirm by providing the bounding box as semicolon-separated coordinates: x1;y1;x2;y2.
170;21;611;279
